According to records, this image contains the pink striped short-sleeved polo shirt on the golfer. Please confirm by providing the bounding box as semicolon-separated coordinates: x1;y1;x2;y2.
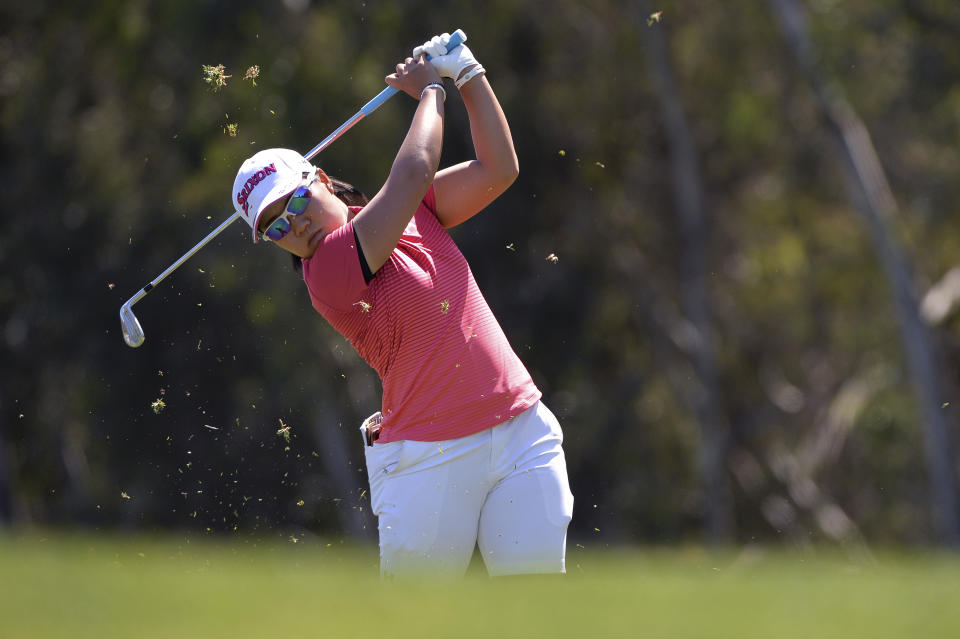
303;187;540;443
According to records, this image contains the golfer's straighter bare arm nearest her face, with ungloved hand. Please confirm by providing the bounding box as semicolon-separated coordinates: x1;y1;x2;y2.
353;57;444;273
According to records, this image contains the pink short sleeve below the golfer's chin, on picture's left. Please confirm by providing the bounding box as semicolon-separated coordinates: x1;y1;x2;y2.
303;220;367;311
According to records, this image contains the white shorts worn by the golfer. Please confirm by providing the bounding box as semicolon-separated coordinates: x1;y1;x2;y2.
364;402;573;577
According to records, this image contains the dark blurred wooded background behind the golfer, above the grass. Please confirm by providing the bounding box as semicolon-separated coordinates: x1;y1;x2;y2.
0;0;960;547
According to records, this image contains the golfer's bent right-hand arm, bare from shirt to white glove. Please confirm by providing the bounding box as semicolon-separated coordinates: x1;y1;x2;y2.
434;68;520;228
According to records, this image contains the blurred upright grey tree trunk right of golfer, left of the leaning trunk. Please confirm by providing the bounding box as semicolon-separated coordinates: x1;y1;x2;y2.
637;0;731;544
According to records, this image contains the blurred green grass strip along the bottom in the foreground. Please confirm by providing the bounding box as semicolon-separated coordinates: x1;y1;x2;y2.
0;533;960;639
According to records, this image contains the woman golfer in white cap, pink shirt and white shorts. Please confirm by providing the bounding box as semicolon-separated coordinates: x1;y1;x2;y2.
232;34;573;577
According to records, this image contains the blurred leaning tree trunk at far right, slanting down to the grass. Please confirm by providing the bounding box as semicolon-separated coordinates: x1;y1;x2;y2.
770;0;960;546
